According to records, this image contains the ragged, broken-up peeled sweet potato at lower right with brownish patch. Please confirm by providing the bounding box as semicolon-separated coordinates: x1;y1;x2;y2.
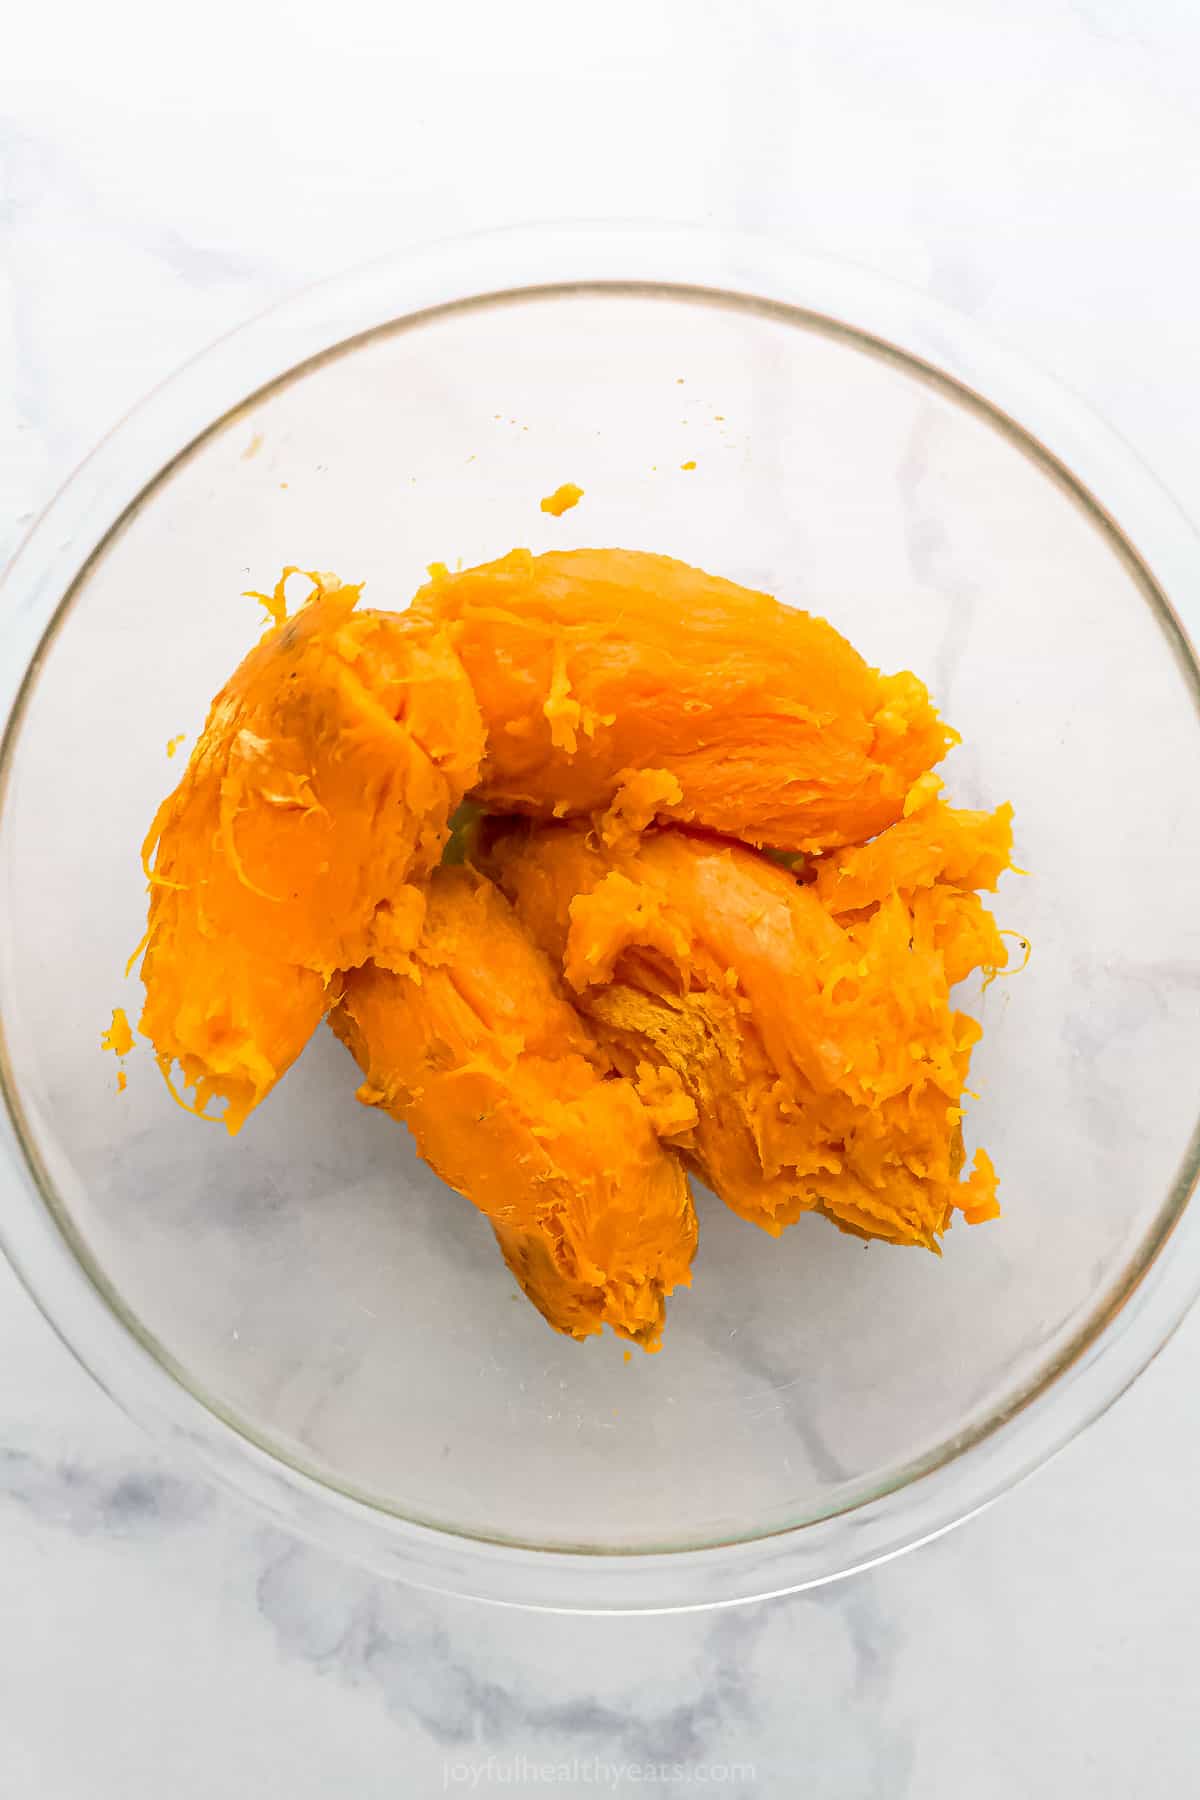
488;803;1009;1249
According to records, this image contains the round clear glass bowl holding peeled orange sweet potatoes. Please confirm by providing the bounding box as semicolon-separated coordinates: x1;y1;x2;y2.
0;217;1200;1609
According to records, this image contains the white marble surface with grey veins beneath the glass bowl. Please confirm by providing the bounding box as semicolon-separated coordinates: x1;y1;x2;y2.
0;0;1200;1800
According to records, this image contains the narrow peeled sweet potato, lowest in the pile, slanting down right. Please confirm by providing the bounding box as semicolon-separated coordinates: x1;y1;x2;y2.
331;868;696;1350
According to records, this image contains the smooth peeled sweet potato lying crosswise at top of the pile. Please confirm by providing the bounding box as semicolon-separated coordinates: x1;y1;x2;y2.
414;549;954;851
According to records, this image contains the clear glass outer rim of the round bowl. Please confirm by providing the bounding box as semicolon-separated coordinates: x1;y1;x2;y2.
0;223;1200;1613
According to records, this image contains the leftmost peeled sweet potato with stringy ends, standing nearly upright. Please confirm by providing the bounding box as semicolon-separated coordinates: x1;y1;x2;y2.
140;576;482;1132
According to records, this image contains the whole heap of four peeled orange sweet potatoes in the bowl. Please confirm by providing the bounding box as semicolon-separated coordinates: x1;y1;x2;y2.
129;532;1011;1350
